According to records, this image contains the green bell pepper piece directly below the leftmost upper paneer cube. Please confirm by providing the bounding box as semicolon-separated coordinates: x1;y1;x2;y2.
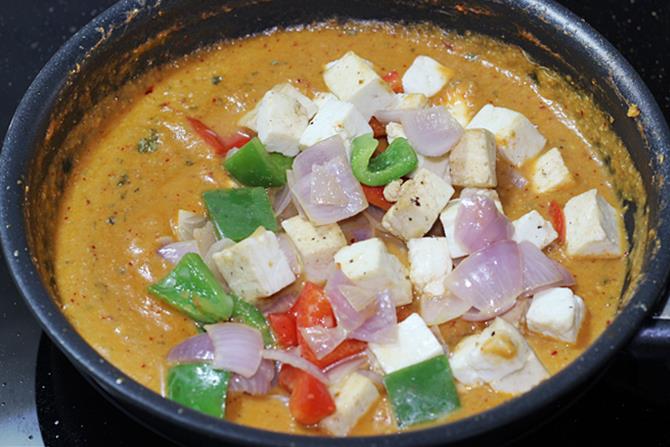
223;137;293;188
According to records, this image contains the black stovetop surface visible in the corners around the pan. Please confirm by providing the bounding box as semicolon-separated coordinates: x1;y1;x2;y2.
0;0;670;447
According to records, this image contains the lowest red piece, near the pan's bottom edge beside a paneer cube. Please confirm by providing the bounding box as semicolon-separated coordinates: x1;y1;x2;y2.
288;370;335;425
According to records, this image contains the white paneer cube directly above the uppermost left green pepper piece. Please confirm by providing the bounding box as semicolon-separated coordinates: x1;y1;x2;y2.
256;90;316;157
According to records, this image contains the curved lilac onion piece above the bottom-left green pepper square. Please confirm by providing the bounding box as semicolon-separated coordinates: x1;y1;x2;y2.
205;323;263;378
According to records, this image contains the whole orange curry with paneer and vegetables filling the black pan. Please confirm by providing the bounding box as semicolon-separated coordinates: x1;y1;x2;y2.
55;22;638;436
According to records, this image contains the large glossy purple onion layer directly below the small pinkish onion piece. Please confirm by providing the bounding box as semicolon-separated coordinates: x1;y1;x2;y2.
446;241;523;314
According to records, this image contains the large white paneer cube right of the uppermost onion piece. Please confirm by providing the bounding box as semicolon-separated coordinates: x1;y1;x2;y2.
468;104;547;167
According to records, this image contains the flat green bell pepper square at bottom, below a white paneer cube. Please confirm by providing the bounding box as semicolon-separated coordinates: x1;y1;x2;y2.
384;355;461;427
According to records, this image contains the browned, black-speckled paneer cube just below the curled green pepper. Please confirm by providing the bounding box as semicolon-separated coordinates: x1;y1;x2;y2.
382;169;454;241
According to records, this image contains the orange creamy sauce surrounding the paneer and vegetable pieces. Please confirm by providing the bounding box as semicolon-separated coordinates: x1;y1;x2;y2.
54;24;639;435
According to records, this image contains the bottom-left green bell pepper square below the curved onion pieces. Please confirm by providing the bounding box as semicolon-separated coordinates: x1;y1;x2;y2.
167;363;230;418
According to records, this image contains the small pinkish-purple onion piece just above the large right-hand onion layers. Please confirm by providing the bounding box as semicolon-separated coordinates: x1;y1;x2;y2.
454;194;514;253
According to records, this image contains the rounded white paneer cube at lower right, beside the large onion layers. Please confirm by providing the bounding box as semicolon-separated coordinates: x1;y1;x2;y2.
526;287;585;343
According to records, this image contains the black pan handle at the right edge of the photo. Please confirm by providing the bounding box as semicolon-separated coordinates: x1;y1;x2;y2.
628;291;670;360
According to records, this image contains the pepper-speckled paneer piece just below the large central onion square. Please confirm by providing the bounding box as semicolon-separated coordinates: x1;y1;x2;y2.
281;216;347;283
